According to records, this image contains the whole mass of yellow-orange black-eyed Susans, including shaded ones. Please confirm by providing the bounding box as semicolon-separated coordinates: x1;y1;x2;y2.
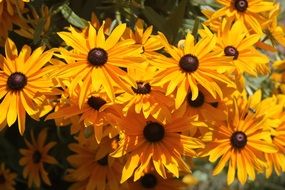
0;0;285;190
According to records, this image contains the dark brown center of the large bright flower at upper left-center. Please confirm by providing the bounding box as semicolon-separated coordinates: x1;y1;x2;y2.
87;48;108;67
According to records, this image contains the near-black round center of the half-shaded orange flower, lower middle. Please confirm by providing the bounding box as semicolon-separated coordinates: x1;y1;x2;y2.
143;122;165;142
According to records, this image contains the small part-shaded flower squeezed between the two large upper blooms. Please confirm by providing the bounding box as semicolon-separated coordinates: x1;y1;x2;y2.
116;66;174;123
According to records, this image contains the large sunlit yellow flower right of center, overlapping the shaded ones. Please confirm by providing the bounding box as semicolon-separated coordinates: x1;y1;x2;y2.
153;30;235;109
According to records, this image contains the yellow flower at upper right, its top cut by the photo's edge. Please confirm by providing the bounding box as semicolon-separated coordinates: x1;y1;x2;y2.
207;0;274;34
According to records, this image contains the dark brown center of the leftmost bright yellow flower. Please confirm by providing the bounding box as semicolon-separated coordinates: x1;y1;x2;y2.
7;72;28;91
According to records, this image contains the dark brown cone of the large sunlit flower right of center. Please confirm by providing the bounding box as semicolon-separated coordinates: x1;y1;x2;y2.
179;54;199;73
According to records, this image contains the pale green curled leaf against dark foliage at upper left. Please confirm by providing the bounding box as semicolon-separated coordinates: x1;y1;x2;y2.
58;4;88;28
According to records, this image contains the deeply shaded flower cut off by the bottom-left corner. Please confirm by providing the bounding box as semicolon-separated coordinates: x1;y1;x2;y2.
0;163;17;190
